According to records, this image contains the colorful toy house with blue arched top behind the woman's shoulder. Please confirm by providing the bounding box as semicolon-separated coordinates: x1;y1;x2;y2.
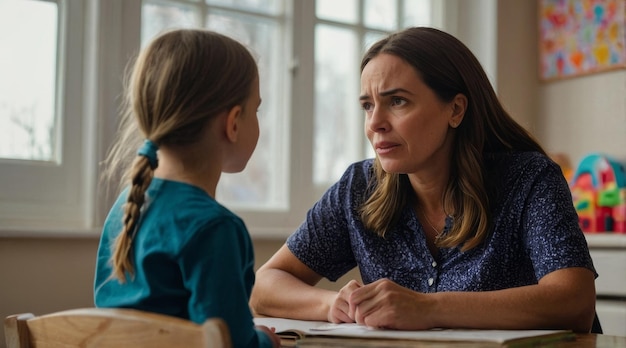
570;154;626;233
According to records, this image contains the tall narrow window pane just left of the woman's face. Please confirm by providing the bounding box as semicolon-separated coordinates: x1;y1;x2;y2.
313;24;363;184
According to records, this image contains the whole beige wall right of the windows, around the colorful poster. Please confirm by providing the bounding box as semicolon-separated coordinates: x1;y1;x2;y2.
494;0;626;167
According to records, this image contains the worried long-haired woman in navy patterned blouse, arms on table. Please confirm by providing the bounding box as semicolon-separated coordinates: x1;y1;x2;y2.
251;28;597;332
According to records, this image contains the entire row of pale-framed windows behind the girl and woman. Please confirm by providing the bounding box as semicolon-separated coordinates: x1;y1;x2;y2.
0;0;439;237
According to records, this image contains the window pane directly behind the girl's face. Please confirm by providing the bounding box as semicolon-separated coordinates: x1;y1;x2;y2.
207;12;288;210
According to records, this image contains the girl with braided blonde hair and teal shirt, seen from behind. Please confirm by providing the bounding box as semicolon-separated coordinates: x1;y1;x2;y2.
95;30;279;347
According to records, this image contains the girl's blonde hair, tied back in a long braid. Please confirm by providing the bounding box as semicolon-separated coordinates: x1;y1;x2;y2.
103;29;258;282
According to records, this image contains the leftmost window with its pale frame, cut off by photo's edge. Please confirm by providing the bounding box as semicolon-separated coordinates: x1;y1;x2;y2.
0;0;90;228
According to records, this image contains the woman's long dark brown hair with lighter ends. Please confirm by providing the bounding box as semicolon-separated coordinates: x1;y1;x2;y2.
360;27;545;250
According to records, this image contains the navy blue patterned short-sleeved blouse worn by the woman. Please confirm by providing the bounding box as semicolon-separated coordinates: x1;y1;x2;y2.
287;152;597;292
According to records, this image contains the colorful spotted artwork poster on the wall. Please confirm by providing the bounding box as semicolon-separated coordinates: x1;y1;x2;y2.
539;0;626;80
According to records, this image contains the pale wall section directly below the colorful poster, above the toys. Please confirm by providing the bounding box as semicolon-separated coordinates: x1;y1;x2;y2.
536;70;626;164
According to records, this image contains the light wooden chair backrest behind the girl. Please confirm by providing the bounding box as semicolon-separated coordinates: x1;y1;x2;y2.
4;308;232;348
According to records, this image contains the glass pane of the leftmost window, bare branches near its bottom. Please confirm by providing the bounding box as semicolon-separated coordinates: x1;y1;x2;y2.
0;0;58;161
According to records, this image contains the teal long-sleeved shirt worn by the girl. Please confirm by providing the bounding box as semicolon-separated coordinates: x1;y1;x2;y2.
94;178;272;347
